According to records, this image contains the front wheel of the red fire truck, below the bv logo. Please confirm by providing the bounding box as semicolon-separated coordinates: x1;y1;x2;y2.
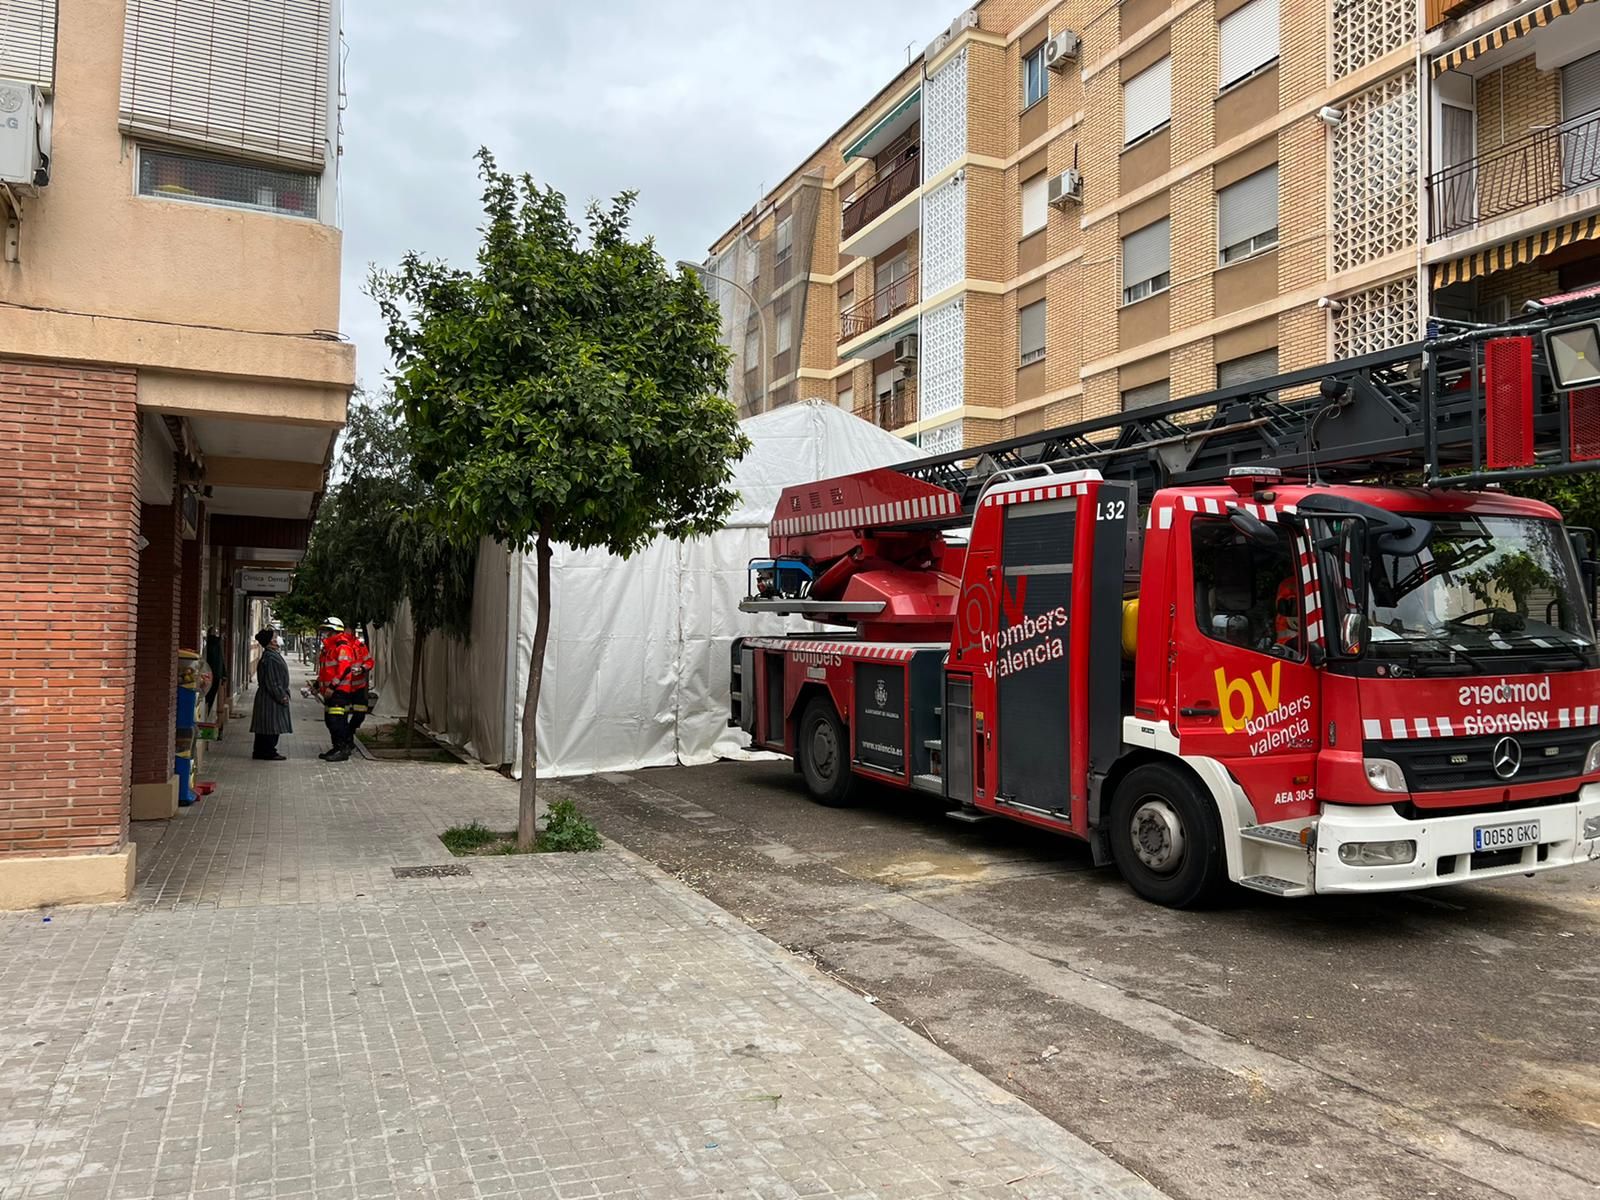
1110;763;1227;909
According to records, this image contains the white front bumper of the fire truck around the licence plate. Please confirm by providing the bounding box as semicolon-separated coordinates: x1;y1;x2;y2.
1312;784;1600;893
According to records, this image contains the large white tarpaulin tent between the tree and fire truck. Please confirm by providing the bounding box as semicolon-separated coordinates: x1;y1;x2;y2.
378;402;918;776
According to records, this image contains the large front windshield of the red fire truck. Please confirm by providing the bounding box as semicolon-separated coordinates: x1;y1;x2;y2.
1366;514;1594;667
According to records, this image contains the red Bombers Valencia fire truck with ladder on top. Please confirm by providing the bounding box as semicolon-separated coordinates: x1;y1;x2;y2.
730;298;1600;906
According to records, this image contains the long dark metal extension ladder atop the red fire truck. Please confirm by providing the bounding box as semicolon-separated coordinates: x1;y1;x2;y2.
896;294;1600;523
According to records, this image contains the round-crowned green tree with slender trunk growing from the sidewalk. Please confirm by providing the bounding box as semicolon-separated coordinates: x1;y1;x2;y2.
371;150;749;850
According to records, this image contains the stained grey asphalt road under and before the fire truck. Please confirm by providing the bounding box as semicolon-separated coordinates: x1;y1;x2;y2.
566;762;1600;1200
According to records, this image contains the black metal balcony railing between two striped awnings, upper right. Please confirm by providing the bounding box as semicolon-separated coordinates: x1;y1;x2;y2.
1427;112;1600;238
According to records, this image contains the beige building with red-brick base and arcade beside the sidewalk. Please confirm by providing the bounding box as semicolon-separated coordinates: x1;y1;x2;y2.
0;0;355;907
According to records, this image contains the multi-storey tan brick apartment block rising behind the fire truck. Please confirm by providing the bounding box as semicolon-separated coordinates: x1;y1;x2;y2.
706;0;1600;453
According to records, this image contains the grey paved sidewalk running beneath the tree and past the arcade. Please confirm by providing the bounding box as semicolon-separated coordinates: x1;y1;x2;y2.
0;699;1158;1200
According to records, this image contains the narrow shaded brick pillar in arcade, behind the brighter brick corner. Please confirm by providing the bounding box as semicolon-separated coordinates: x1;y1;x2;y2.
133;489;184;784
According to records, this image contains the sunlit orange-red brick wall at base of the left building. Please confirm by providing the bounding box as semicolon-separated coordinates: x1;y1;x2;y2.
0;362;139;856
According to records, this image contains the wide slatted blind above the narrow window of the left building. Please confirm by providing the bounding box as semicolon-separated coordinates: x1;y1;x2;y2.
119;0;333;170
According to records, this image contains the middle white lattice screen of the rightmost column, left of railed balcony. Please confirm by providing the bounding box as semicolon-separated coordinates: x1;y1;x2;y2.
1333;70;1421;272
